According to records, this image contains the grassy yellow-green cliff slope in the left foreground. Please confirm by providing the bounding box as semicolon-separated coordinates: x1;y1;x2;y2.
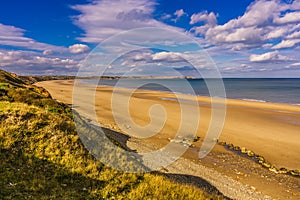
0;70;223;199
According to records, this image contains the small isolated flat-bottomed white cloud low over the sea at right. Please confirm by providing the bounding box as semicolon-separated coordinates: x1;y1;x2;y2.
250;51;293;62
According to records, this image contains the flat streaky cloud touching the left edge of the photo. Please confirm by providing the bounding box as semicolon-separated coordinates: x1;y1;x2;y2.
0;24;66;52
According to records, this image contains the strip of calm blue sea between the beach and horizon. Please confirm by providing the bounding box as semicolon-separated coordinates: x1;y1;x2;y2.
88;78;300;105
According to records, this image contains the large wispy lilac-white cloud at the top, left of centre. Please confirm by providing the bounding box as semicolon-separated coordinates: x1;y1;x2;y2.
72;0;181;43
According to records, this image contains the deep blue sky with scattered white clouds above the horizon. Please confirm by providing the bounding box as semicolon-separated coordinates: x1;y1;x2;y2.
0;0;300;77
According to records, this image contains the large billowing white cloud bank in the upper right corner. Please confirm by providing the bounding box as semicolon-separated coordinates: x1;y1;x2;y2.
190;0;300;50
